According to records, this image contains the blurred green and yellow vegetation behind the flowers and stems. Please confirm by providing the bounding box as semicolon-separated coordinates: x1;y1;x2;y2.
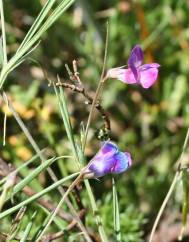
0;0;189;242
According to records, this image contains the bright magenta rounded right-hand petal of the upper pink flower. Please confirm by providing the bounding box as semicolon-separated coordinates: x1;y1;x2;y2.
139;63;159;88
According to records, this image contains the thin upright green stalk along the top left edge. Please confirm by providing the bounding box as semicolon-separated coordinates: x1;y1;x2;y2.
0;0;7;66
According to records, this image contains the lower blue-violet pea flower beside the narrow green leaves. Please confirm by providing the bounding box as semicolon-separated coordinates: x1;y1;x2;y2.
87;142;132;177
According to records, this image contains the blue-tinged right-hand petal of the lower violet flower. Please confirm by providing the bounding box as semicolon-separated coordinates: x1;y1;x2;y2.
111;152;132;174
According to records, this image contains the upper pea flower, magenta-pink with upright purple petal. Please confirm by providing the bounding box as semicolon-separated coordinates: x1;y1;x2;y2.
107;45;160;88
